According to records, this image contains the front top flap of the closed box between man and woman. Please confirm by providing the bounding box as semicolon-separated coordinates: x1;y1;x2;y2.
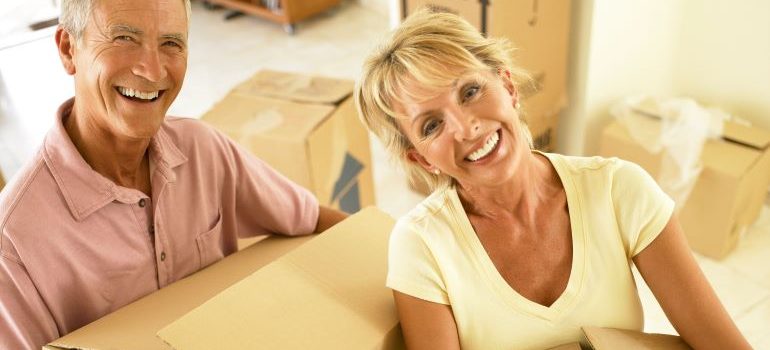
201;93;334;145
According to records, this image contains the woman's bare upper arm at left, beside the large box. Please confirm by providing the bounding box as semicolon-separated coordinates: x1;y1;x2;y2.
393;290;460;350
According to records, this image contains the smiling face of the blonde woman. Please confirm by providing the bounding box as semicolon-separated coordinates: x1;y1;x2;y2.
396;71;529;187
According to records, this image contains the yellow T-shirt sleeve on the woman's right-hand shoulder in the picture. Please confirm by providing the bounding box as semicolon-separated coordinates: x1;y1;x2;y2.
612;160;674;258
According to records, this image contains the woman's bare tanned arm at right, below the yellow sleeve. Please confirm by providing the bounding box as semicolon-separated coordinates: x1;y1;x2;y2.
634;215;751;349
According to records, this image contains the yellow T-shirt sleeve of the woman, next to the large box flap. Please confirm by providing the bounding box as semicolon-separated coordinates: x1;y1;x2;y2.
386;218;449;305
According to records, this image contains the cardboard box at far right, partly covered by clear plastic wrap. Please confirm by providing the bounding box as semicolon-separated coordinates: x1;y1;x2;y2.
599;118;770;259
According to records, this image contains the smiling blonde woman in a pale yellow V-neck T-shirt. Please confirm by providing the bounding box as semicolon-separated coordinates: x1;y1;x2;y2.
356;12;749;349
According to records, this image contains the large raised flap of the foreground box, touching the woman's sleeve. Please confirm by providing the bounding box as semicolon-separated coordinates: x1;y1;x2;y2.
158;208;402;350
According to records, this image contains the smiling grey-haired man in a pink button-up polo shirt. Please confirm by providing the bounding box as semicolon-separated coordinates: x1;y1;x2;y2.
0;0;345;349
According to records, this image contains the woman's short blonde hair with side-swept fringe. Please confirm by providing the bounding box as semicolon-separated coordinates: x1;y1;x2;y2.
355;10;532;190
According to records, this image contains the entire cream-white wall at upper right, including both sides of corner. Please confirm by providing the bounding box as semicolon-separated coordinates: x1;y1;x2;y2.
559;0;770;154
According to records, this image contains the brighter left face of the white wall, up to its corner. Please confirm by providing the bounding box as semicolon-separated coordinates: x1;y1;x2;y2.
559;0;683;154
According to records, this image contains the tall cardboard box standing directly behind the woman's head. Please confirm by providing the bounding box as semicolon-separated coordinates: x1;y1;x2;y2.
401;0;571;150
